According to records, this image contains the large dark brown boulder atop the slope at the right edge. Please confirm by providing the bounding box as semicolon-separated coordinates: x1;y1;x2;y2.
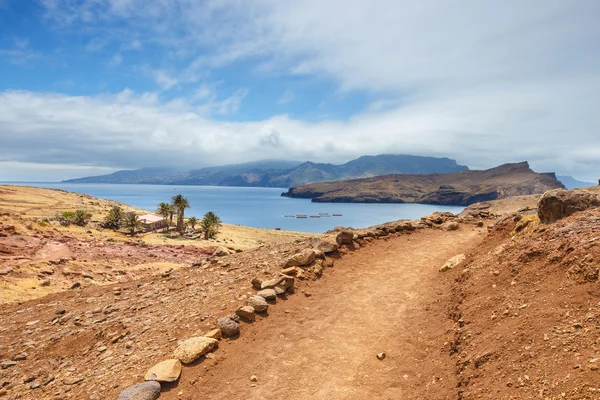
538;189;600;223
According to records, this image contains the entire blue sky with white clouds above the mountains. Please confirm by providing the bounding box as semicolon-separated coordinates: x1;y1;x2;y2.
0;0;600;181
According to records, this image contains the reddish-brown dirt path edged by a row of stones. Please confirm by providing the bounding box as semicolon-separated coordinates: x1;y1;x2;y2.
161;226;483;400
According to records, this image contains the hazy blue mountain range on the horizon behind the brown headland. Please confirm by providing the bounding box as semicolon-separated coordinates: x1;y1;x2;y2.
63;154;469;188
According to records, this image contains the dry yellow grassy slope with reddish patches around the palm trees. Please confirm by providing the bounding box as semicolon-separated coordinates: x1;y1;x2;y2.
0;186;316;302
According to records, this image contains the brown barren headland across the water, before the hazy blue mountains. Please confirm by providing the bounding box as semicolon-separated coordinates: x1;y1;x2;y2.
282;162;564;206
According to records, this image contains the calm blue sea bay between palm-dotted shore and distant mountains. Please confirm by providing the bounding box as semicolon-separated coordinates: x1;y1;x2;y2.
1;182;463;232
